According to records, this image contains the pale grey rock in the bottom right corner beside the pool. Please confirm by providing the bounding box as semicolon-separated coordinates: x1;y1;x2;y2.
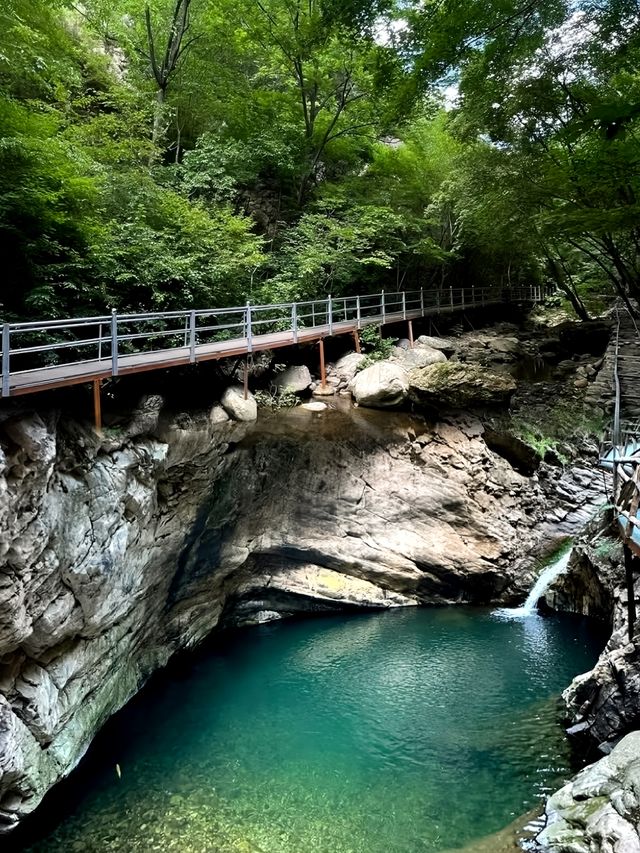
537;732;640;853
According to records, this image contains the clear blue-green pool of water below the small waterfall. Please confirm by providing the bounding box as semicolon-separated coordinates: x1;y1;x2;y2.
16;608;602;853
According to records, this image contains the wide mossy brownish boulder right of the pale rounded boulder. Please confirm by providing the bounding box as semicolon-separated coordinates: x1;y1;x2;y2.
409;361;516;409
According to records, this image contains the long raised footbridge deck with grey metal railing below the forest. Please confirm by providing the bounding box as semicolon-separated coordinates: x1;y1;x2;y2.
1;286;545;397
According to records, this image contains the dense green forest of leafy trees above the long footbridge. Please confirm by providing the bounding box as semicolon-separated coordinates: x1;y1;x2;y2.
0;0;640;320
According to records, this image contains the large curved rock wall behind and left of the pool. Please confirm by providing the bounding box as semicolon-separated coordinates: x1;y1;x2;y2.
0;395;600;831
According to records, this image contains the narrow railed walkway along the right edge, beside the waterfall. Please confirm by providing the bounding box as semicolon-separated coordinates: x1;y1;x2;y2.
600;306;640;639
